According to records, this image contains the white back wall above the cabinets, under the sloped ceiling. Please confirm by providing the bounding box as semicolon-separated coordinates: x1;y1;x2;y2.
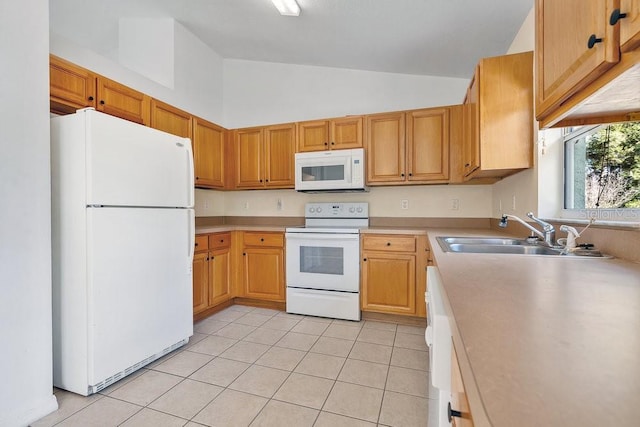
224;59;471;128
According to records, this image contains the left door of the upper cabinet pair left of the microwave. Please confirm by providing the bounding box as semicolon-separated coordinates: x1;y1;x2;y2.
235;128;264;188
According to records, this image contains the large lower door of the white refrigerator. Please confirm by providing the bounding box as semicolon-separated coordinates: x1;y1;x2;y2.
87;208;194;386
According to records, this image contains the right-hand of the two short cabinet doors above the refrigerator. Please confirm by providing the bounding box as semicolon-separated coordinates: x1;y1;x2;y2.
96;76;151;126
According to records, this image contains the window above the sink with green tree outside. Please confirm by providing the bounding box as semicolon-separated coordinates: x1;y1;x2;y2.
564;122;640;219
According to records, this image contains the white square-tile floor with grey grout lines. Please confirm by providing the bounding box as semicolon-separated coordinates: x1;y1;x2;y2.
32;305;436;427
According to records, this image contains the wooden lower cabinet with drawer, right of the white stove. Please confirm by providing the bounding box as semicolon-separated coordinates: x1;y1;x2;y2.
361;234;428;317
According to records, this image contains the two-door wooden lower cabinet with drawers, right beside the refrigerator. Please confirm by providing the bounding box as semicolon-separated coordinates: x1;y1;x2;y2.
193;233;233;315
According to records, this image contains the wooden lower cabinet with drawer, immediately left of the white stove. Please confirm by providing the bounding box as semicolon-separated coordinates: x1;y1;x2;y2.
241;232;285;302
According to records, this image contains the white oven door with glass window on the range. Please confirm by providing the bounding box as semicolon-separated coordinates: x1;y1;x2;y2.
286;232;360;292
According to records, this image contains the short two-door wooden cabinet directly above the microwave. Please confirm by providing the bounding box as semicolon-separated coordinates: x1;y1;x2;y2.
298;116;363;152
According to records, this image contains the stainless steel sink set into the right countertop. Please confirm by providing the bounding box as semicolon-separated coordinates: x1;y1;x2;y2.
436;237;611;258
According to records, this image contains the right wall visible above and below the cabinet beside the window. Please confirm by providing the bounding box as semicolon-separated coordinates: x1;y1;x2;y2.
492;8;540;218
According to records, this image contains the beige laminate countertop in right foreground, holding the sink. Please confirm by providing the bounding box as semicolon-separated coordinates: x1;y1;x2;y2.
428;229;640;427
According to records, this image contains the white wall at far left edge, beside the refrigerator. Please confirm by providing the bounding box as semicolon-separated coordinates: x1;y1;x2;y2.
0;0;57;427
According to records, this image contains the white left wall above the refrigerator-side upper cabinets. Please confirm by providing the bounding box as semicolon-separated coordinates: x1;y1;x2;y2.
50;21;224;124
